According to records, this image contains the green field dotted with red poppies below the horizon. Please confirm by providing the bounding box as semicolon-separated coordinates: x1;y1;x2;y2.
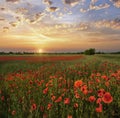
0;55;120;118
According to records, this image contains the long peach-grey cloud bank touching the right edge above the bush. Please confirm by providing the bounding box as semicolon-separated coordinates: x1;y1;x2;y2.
95;18;120;30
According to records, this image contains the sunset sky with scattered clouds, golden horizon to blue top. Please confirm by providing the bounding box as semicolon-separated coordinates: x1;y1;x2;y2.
0;0;120;52
